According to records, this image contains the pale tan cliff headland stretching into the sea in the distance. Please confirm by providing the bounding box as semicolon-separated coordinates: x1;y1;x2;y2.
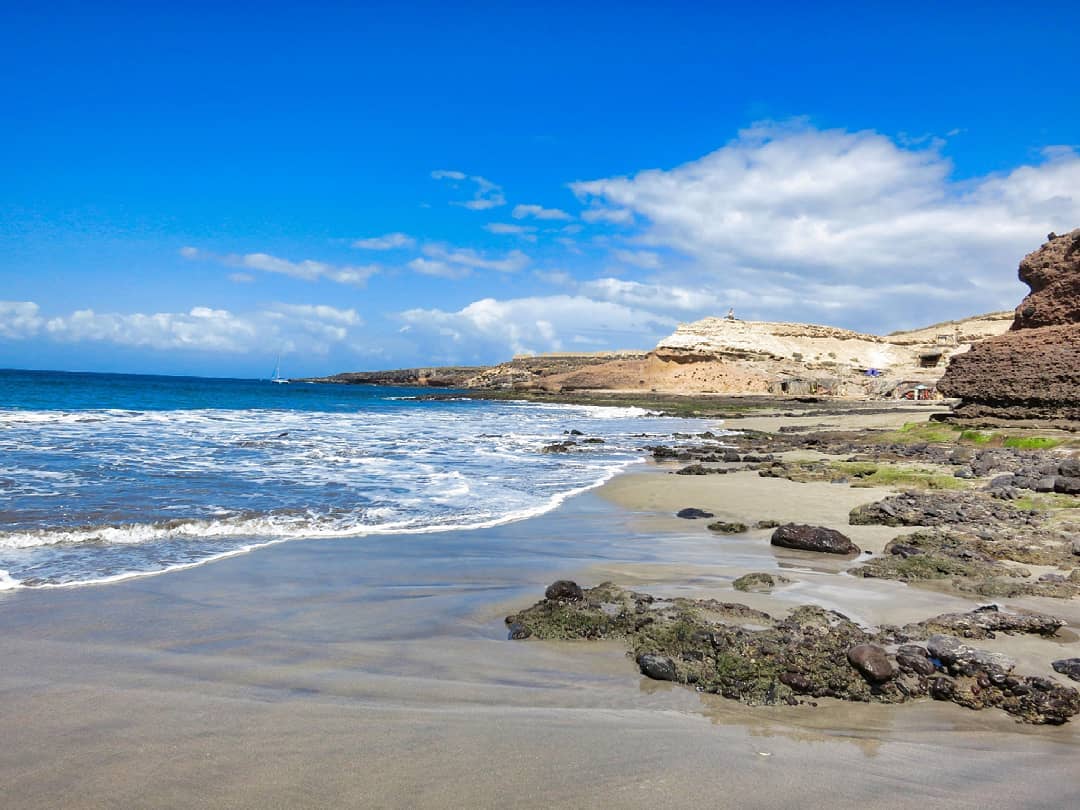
319;312;1013;397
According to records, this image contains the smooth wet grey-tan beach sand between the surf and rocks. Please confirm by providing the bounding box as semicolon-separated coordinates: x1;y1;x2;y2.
0;408;1080;809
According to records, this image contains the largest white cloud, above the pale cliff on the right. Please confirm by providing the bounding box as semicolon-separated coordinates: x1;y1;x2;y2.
572;121;1080;330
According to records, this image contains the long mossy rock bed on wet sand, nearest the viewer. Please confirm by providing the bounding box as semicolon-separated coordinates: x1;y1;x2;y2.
507;582;1080;724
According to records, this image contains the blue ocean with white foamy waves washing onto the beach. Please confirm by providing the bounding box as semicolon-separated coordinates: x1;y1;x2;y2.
0;370;715;589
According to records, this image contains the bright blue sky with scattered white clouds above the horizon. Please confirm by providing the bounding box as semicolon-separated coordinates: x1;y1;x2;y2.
0;2;1080;376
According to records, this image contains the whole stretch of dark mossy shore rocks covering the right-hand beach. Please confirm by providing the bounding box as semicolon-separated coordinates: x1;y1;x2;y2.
505;411;1080;725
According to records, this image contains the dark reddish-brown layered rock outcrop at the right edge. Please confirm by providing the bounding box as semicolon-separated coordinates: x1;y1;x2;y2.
939;228;1080;420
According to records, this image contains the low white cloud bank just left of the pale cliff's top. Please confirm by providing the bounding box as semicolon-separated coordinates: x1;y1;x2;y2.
400;295;676;362
